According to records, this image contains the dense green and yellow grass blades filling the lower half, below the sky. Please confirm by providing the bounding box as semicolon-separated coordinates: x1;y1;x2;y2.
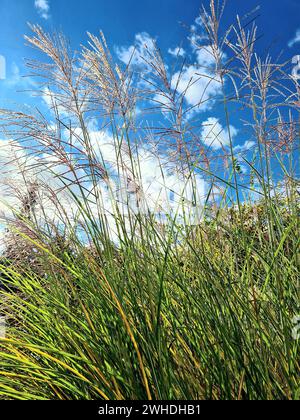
0;195;299;399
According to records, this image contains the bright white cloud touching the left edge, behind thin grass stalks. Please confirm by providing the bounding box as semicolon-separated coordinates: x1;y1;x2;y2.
0;140;82;230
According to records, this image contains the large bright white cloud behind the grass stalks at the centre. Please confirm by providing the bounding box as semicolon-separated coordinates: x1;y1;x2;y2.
86;131;206;216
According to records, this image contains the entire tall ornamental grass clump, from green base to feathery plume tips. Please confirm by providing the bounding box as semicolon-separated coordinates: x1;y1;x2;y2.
0;1;300;400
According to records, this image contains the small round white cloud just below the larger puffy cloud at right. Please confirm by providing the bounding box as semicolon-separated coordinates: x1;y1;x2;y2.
201;117;238;150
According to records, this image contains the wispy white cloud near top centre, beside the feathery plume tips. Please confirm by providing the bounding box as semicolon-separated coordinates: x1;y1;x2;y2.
115;32;154;67
